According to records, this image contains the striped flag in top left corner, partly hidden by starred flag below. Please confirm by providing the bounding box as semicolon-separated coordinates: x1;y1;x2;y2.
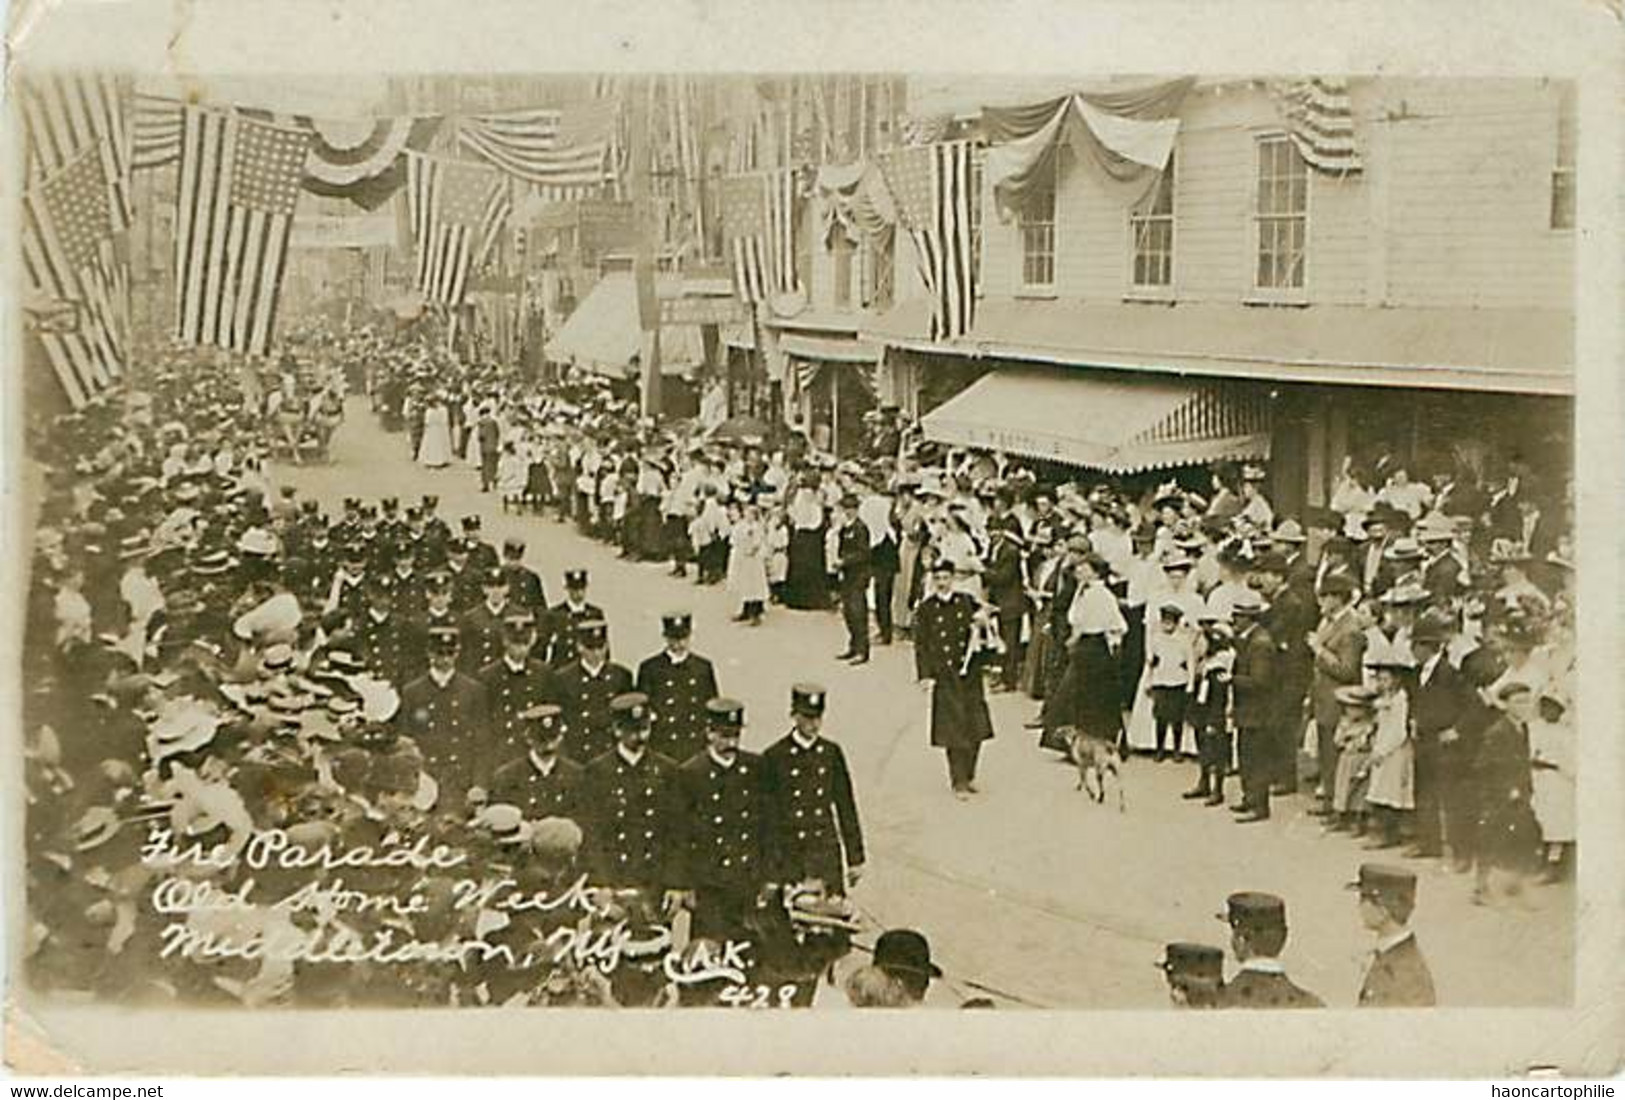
18;73;132;232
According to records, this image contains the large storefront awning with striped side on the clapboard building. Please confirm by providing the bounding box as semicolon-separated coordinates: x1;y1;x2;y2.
921;369;1269;473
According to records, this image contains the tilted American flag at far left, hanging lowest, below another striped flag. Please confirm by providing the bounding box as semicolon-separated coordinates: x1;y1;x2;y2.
23;146;127;408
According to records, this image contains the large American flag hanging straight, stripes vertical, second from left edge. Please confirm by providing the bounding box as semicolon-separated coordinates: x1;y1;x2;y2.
176;104;310;354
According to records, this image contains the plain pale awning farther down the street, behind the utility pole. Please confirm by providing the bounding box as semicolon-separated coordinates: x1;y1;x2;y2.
544;271;705;379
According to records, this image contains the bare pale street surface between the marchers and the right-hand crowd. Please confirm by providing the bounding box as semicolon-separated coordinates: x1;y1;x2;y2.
273;396;1575;1009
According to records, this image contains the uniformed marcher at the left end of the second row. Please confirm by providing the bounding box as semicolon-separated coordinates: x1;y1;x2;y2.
400;627;491;809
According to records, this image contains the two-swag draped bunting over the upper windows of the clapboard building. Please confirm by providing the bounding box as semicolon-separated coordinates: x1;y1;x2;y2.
982;76;1196;218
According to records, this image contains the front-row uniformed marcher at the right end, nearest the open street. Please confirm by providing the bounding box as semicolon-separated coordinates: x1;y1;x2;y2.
762;684;865;894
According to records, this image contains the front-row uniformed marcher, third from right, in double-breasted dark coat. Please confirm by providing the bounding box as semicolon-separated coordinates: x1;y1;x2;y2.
580;692;681;897
